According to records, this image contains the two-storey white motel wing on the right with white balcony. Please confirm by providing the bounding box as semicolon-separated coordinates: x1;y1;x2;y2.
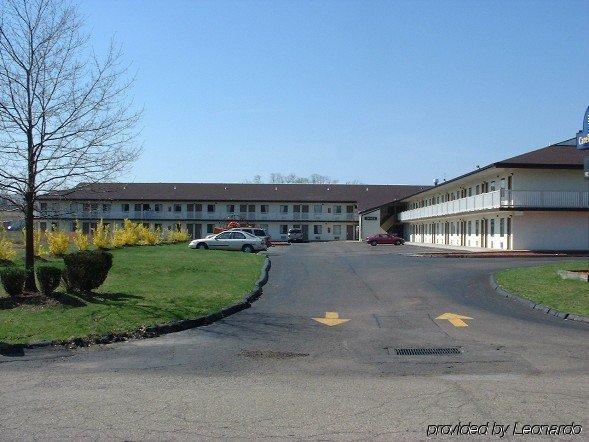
359;138;589;251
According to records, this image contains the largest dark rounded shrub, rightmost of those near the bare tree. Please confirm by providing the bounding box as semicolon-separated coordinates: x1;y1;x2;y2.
62;250;112;293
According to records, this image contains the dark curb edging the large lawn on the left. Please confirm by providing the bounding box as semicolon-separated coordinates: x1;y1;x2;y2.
0;256;272;353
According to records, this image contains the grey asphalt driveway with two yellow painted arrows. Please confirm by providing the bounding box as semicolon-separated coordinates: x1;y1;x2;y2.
0;242;589;440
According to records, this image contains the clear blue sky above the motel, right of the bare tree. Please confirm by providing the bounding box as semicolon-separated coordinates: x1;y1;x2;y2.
81;0;589;184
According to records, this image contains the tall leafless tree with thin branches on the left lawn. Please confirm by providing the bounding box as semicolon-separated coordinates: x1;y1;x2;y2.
0;0;140;291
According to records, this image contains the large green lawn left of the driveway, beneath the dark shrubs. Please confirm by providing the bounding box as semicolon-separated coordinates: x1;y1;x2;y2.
0;244;265;343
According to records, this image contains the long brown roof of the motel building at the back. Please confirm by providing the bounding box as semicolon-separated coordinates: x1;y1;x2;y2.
41;183;429;210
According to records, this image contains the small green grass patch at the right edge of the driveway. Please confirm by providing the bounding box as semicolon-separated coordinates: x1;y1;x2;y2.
497;260;589;316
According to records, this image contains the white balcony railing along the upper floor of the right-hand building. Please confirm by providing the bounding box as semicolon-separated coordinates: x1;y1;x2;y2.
399;189;589;221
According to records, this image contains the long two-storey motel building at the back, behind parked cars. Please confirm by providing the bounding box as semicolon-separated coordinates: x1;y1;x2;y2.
36;183;427;241
